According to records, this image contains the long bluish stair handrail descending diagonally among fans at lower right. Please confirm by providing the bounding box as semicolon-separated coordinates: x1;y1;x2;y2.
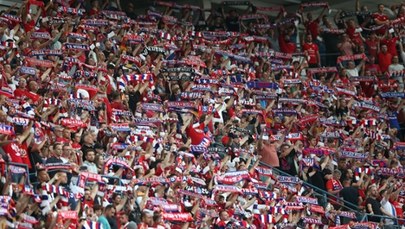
260;162;398;226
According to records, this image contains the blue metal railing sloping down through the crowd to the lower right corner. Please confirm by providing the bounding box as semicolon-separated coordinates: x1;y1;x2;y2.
260;162;401;225
